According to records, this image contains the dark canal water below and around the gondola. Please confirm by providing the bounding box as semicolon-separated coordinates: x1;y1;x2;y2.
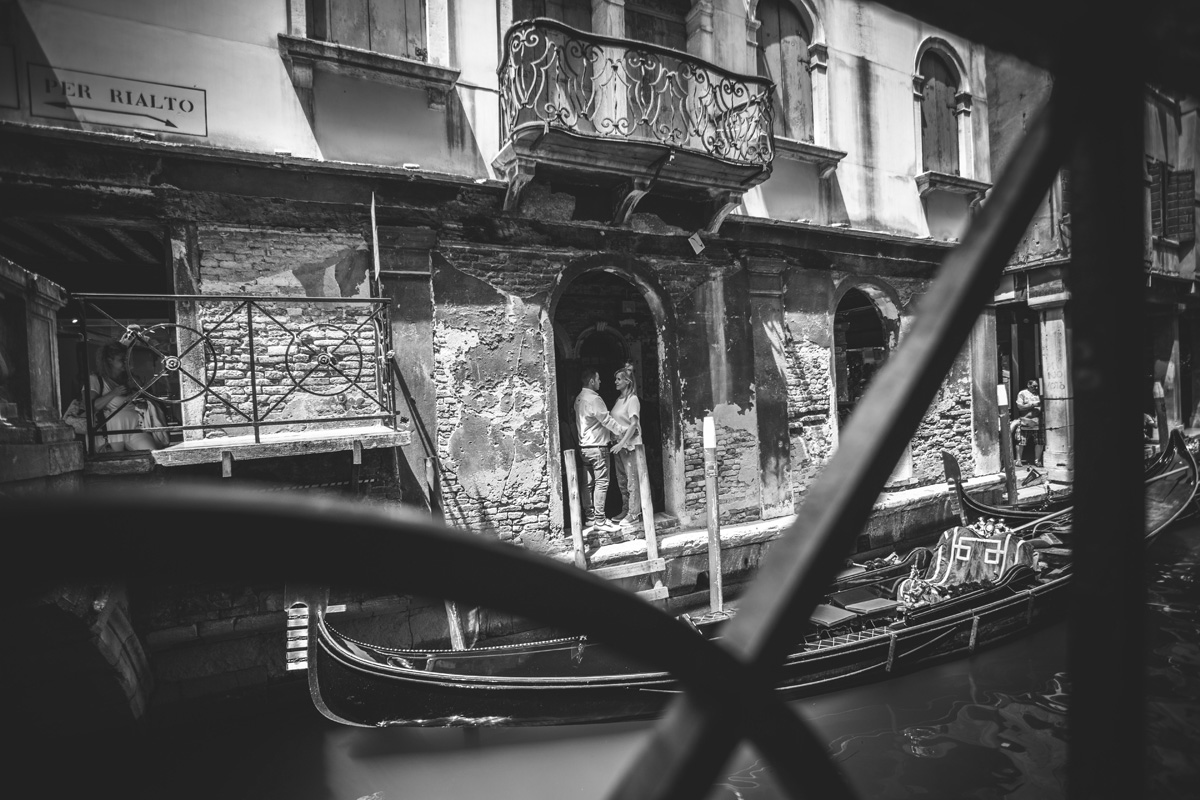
82;523;1200;800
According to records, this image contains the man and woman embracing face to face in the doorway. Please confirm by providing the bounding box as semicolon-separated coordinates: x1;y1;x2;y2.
575;362;642;534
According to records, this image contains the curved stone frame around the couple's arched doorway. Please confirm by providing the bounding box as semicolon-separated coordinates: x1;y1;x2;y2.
541;254;685;534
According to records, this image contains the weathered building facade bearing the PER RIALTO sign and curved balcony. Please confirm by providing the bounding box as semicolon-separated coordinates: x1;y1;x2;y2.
0;0;998;719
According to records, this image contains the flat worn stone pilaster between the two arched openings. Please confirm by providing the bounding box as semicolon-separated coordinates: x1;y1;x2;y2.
748;259;793;519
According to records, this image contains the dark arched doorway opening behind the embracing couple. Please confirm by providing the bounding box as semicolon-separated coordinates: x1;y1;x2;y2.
553;270;666;528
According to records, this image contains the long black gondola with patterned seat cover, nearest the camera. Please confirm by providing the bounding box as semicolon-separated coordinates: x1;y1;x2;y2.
307;433;1196;727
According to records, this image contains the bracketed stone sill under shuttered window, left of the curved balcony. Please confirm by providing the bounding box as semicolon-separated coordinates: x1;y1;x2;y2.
278;34;458;108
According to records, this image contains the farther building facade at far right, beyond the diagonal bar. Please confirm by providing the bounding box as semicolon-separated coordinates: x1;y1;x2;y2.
980;50;1200;482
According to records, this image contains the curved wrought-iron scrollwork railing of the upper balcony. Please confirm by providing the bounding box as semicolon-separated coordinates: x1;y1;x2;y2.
499;19;774;167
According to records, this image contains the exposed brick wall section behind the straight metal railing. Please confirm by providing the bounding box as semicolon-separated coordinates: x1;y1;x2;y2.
195;228;384;437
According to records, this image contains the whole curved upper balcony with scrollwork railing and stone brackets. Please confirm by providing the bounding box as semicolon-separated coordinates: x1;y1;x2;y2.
494;19;775;230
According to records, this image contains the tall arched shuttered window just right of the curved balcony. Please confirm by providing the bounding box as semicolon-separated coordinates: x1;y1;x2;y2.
758;0;812;142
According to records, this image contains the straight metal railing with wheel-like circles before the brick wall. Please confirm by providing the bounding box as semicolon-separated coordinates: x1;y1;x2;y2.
74;294;395;453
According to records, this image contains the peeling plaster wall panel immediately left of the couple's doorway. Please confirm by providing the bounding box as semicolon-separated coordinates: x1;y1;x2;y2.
433;260;552;549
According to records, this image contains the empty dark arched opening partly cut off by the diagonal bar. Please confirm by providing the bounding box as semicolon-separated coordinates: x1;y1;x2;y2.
833;289;890;428
